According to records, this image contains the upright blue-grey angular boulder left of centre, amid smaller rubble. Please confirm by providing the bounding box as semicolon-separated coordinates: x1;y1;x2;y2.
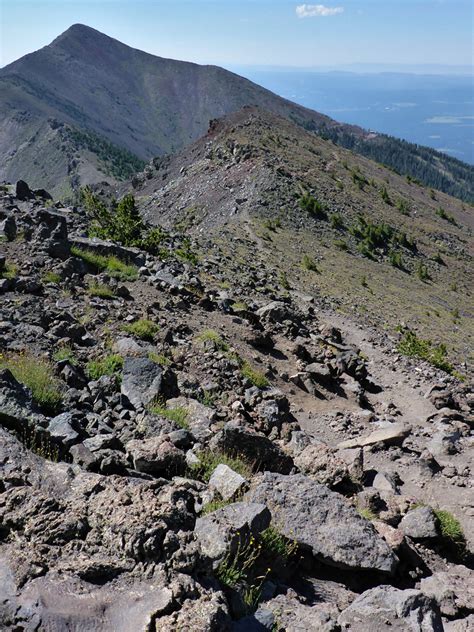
121;357;163;408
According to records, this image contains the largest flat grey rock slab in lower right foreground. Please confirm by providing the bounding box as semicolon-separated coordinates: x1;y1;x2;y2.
247;472;398;573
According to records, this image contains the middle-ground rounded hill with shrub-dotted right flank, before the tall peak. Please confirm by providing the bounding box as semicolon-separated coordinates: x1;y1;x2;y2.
134;108;474;368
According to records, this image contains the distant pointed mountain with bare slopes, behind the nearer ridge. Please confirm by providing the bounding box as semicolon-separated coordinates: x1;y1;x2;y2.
0;24;474;199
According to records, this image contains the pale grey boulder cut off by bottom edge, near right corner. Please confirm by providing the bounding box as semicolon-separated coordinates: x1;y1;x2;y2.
338;586;443;632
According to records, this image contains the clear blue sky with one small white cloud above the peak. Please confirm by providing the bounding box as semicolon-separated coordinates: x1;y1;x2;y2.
0;0;473;67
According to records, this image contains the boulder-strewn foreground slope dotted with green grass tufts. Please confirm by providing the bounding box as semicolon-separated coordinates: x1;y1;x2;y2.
0;183;474;632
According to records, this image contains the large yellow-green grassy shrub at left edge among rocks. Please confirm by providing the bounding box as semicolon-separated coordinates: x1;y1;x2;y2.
0;353;64;415
